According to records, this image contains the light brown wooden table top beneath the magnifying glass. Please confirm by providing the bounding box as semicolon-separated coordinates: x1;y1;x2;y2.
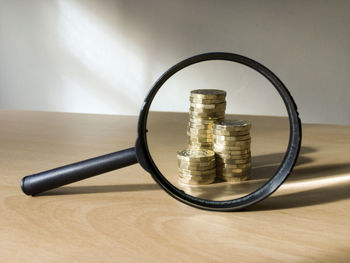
0;110;350;262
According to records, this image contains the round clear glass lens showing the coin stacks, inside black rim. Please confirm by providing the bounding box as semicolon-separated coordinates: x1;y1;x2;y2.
147;61;289;201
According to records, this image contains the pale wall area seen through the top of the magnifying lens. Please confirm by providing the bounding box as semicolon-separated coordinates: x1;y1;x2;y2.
151;61;287;116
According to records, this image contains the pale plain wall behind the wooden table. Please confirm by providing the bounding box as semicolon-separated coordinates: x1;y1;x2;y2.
0;0;350;124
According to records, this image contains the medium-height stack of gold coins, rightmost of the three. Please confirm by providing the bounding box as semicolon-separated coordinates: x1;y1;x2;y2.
213;120;251;182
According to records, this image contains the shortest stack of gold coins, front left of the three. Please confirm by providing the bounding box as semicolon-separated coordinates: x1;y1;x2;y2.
177;149;216;185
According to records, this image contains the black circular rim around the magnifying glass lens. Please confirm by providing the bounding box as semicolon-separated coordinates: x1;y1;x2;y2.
137;52;302;211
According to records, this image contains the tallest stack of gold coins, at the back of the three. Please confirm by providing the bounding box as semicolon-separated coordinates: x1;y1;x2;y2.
187;89;226;149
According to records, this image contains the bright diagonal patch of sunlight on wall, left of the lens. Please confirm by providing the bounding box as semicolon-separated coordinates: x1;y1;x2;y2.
57;0;145;115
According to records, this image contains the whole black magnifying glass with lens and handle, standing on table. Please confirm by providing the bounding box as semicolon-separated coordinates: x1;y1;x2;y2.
21;52;302;211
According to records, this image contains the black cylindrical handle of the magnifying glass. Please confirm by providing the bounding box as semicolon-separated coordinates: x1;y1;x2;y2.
21;147;138;195
